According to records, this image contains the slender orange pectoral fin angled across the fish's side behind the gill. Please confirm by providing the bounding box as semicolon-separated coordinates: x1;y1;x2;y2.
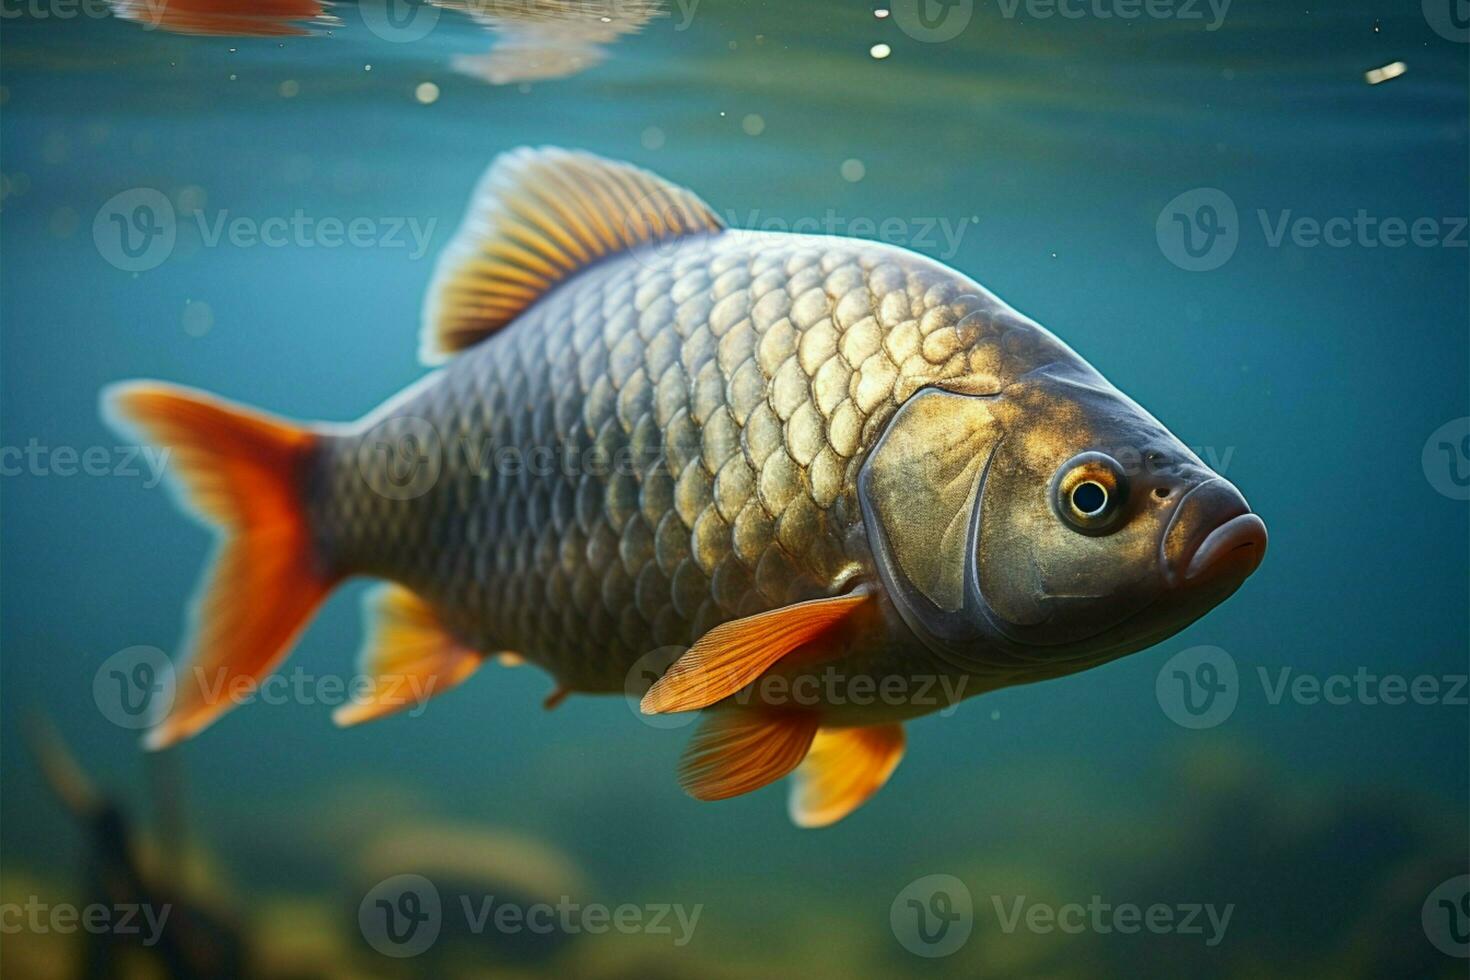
639;592;873;714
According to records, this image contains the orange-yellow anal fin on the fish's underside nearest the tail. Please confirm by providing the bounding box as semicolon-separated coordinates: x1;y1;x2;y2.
332;585;485;727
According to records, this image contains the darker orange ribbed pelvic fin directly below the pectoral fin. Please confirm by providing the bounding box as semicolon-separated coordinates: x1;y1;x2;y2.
679;711;817;799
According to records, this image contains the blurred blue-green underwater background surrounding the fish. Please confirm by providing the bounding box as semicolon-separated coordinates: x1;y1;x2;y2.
0;0;1470;977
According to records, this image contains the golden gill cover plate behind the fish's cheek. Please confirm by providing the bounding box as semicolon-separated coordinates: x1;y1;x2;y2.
857;388;1003;652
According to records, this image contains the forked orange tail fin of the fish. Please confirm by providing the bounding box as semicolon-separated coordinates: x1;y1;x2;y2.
103;382;335;749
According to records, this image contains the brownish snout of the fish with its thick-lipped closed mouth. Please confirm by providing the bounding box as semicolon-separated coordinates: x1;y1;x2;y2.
1160;476;1266;589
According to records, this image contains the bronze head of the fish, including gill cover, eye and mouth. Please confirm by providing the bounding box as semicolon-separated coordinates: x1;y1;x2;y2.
858;364;1266;676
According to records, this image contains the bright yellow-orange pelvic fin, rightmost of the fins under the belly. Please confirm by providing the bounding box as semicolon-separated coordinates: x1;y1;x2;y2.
789;724;904;827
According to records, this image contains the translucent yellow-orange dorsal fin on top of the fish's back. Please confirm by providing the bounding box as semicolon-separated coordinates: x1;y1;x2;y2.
419;147;725;363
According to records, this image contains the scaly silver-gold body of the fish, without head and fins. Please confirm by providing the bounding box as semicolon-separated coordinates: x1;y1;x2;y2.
310;231;1017;691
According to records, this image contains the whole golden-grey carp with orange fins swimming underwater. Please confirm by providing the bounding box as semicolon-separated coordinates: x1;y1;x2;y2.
103;147;1267;827
